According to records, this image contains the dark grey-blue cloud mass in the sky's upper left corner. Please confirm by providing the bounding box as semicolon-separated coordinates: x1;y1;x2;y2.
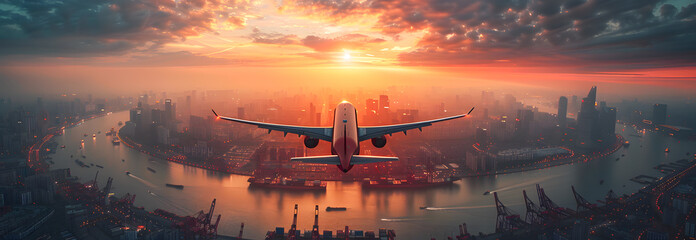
0;0;246;57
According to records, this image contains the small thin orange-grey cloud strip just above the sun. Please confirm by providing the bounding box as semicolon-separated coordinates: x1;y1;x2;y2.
250;29;386;52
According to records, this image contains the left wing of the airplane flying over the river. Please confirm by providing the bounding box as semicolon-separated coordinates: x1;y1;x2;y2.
213;110;333;142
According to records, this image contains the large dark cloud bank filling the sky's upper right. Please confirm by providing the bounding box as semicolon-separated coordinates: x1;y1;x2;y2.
285;0;696;67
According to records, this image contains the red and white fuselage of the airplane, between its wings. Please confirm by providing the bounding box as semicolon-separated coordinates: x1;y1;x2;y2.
331;101;360;172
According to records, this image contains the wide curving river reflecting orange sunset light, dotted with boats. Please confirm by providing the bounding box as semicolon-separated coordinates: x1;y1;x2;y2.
52;112;696;239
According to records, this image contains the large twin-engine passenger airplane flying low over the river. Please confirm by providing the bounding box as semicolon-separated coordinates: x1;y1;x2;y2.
211;101;474;173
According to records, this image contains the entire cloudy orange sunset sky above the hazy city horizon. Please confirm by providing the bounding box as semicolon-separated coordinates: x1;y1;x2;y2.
0;0;696;95
